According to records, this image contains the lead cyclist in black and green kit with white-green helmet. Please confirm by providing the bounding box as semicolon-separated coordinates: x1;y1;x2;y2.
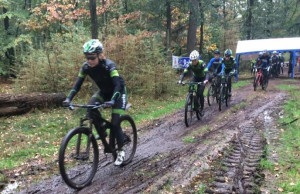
63;39;127;166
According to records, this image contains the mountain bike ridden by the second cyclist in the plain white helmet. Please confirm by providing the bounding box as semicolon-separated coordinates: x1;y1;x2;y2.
183;82;205;127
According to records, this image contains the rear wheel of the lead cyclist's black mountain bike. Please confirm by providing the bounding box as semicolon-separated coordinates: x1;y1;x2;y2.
120;115;137;166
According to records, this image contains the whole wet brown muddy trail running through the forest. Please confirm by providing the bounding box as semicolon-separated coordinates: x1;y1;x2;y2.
9;80;298;193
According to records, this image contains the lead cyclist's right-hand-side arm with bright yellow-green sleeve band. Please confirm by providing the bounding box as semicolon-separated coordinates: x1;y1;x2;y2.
108;61;122;100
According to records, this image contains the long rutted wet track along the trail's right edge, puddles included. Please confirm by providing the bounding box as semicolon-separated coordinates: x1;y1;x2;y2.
186;87;286;193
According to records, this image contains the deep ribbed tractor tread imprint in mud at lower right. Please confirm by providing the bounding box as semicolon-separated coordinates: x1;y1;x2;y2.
206;121;265;193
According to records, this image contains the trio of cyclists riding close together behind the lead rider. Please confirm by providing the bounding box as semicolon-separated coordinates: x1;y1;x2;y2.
178;49;237;116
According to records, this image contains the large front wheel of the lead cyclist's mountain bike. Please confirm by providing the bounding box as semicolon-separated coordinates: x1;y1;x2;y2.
59;127;99;189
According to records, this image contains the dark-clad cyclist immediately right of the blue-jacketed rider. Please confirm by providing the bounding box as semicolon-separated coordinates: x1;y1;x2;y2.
220;49;236;96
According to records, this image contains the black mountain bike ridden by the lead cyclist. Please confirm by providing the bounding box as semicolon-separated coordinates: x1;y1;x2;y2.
58;104;137;189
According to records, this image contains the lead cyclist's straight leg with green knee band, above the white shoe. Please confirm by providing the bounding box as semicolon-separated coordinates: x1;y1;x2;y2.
111;88;127;150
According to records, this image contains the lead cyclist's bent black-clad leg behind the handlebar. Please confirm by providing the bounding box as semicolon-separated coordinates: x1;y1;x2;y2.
87;91;106;137
